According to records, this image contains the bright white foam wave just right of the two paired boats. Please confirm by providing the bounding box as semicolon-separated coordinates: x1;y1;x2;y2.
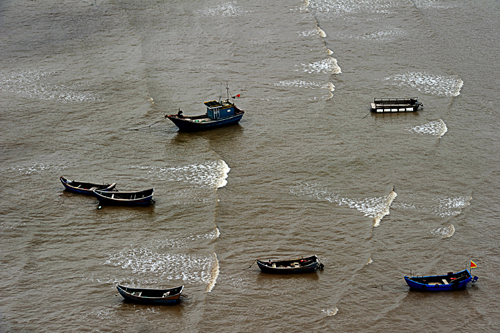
133;160;231;189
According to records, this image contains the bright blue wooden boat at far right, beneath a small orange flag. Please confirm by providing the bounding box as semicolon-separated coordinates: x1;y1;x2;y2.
404;269;477;291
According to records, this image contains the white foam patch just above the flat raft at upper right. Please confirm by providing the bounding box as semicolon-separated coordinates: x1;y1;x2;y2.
386;72;463;97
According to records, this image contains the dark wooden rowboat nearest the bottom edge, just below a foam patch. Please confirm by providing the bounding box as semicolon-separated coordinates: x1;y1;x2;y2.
116;285;184;304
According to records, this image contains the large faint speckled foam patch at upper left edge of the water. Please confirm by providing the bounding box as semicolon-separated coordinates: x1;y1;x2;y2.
0;71;100;103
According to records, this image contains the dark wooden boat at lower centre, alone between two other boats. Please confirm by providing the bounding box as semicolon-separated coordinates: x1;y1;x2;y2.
257;255;324;274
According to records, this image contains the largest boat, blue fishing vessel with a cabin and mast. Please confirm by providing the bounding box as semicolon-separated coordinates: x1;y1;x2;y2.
165;86;245;132
